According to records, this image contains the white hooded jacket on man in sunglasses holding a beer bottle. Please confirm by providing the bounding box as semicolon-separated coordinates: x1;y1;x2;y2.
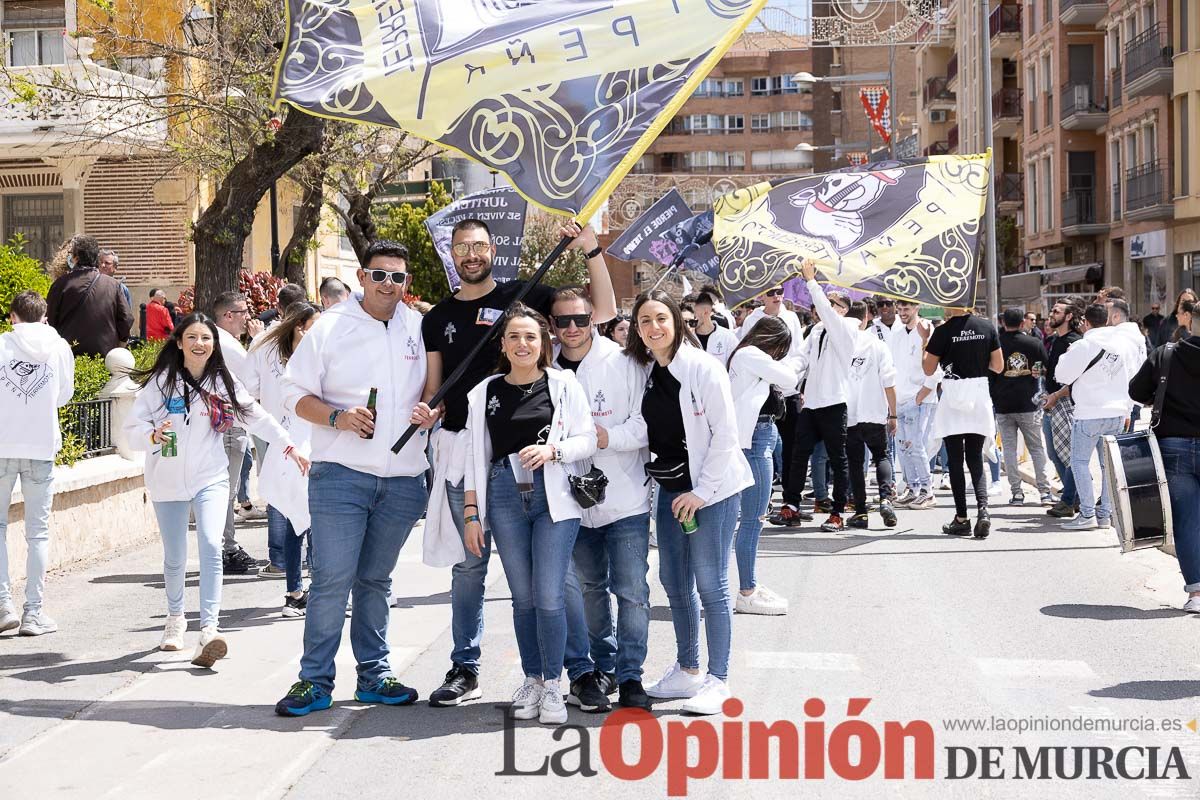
283;293;430;477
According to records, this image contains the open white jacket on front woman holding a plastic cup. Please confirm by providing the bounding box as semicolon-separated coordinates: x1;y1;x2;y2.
463;367;600;531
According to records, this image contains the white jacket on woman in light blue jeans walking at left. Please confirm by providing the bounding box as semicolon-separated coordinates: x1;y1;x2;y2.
125;377;292;503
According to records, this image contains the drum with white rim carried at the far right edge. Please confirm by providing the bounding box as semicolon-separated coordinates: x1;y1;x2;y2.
1104;431;1171;553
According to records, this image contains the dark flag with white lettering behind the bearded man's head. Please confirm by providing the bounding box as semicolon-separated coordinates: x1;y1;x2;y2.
425;186;528;291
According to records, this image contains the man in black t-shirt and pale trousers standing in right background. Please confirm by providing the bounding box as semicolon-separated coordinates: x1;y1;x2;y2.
991;308;1054;506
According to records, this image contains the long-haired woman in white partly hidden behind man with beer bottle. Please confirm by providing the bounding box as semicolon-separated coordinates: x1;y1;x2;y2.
246;301;320;616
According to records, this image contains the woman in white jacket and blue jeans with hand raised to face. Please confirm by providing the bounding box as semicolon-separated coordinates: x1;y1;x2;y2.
728;317;798;615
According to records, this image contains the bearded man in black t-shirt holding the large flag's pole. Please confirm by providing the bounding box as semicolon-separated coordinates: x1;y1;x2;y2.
413;219;617;708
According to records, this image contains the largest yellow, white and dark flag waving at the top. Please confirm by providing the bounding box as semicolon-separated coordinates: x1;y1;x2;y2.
275;0;767;219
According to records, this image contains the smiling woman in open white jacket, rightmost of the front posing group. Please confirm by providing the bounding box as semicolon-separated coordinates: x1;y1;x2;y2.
626;290;754;714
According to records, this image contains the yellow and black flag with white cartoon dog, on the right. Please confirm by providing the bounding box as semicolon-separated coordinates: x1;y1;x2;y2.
713;151;991;308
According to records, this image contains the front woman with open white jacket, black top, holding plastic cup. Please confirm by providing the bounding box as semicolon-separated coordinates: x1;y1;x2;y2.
463;303;596;724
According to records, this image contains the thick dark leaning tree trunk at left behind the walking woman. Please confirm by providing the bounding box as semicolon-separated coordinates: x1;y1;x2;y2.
192;108;325;312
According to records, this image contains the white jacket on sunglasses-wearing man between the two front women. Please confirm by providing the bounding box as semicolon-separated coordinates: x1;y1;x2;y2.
554;331;648;528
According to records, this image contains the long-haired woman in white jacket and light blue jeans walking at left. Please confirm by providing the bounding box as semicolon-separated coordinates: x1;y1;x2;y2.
125;313;308;668
